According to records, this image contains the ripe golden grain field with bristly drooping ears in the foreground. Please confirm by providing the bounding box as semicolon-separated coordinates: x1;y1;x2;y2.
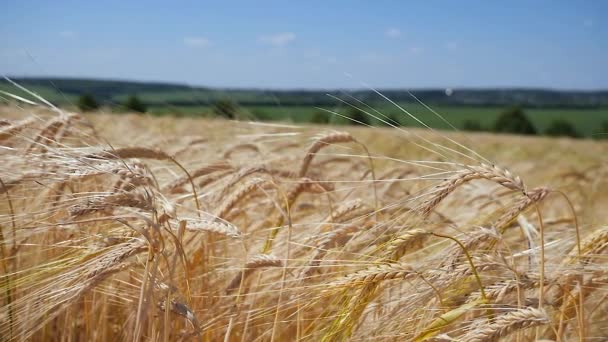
0;95;608;341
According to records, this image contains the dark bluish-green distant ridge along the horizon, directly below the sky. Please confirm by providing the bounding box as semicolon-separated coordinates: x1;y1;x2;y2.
0;78;608;108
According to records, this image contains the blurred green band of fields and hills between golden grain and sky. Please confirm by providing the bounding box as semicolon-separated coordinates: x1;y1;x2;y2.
0;79;608;137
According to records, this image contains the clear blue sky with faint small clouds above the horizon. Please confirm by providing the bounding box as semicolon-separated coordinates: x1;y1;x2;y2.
0;0;608;89
